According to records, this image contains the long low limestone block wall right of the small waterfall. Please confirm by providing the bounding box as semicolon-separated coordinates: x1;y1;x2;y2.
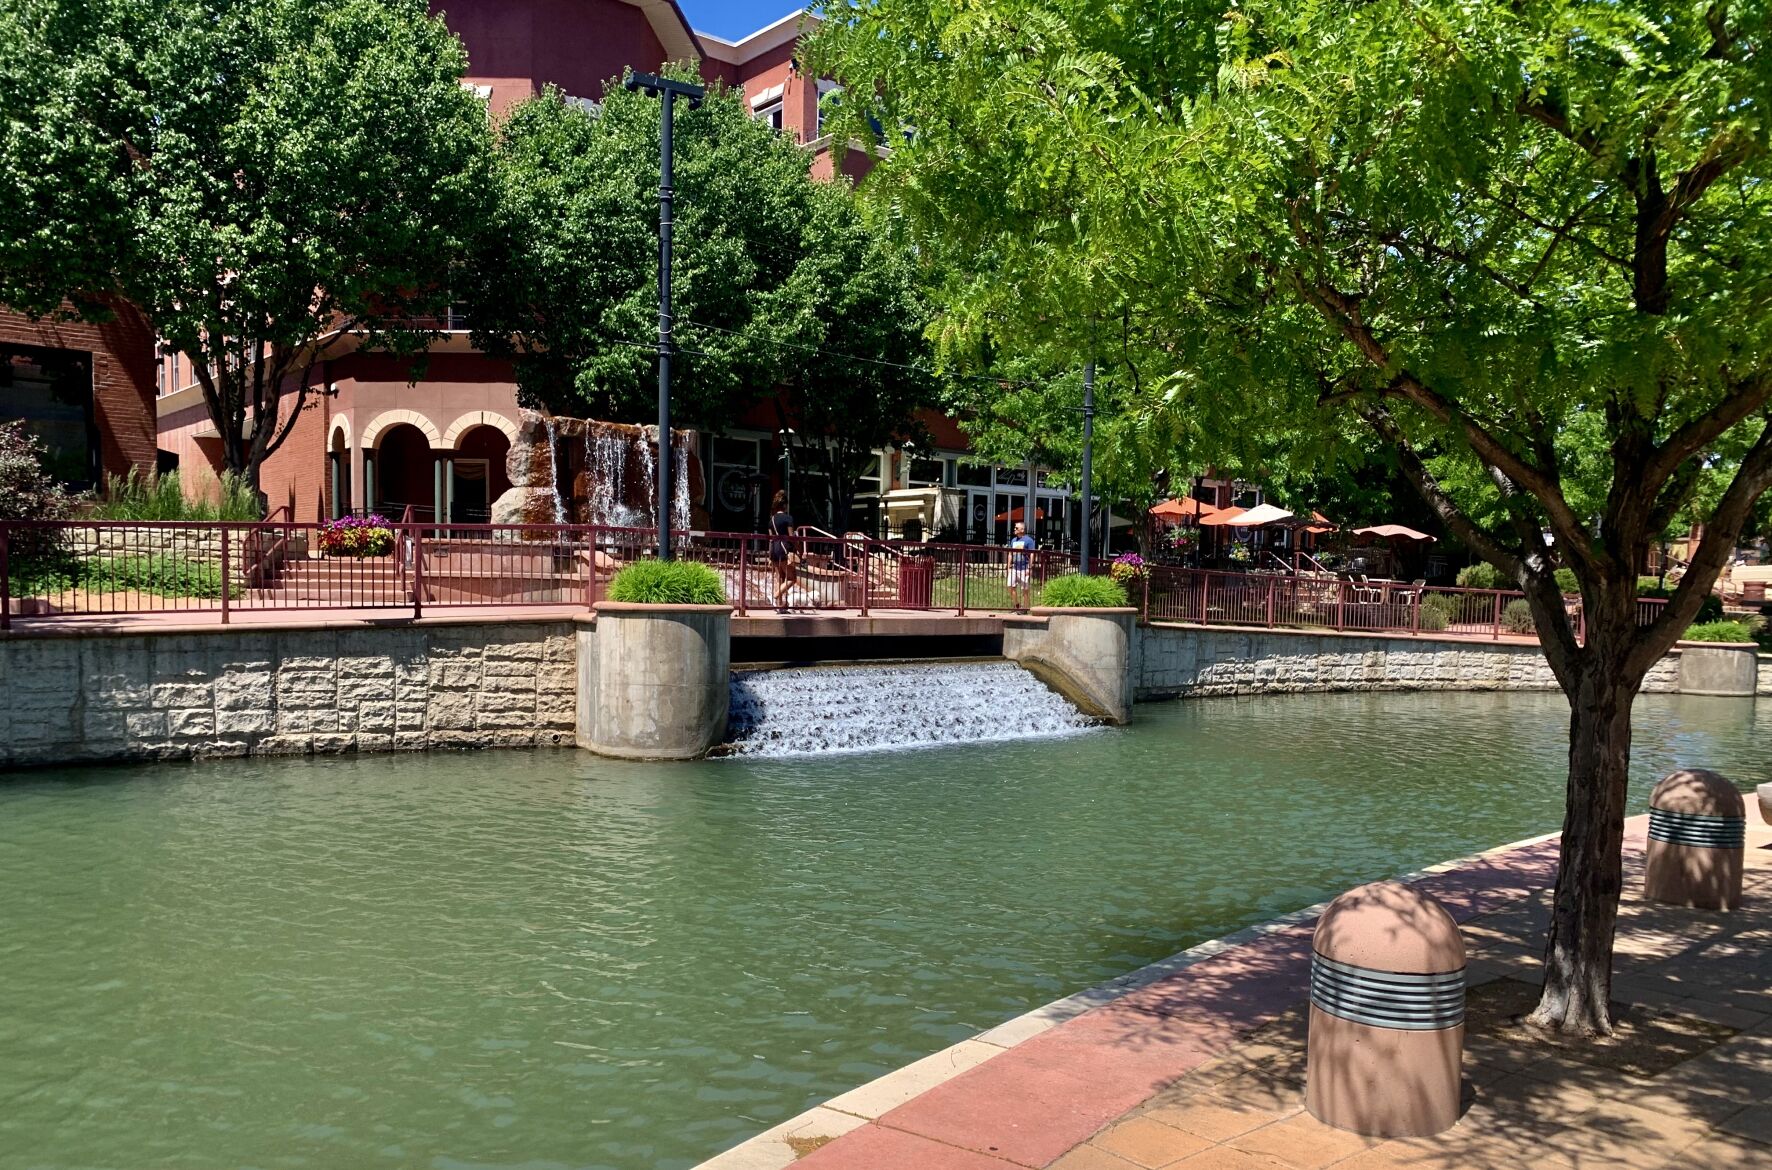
1132;626;1679;702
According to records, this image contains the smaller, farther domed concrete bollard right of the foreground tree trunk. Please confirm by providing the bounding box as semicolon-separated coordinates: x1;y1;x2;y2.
1643;768;1747;909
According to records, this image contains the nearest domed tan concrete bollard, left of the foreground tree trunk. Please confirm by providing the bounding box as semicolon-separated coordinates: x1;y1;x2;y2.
1304;881;1464;1138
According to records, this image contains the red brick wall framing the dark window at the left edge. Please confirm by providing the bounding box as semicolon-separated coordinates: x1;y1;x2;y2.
0;305;154;475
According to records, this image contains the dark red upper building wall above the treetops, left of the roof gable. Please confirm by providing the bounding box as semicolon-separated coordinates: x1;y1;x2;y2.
431;0;665;112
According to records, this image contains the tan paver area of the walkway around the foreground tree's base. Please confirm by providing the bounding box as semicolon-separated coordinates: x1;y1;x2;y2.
1051;819;1772;1170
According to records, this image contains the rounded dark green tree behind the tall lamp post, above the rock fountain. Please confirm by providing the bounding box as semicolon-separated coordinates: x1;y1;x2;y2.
470;74;932;525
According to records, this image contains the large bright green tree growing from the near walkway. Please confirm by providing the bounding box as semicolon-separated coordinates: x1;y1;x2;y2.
817;0;1772;1034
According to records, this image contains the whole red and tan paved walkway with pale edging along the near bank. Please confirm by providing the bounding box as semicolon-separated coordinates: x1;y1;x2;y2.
711;798;1772;1170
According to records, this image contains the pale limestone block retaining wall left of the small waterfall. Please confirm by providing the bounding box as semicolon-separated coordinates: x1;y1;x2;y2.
0;620;576;768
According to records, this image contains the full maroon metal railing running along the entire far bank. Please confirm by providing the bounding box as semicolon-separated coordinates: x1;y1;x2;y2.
0;521;1664;638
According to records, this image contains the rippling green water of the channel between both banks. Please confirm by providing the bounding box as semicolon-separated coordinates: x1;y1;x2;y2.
0;695;1772;1170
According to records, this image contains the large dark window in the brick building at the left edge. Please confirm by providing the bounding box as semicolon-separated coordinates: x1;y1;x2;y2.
0;344;99;491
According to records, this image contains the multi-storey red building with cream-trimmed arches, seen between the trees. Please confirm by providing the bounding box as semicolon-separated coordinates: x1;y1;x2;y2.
148;0;1074;539
